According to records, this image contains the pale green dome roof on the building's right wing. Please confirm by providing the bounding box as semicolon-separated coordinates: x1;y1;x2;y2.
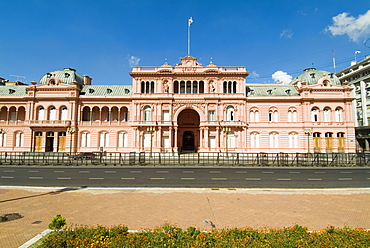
290;68;341;85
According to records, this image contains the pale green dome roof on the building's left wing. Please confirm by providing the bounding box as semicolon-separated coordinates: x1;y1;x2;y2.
39;67;84;88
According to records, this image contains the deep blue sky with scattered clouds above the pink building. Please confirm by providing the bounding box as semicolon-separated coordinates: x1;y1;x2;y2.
0;0;370;85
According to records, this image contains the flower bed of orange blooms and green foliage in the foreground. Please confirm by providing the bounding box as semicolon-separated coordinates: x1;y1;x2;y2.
37;224;370;248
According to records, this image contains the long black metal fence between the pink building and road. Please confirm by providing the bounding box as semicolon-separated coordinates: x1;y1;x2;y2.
0;152;370;167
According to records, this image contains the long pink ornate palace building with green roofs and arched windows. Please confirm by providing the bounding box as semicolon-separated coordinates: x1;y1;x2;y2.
0;56;356;153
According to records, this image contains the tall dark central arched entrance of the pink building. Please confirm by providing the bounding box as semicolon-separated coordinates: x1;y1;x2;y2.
177;109;200;152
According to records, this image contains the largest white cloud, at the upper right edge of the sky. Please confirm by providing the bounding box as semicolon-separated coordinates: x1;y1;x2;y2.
325;10;370;42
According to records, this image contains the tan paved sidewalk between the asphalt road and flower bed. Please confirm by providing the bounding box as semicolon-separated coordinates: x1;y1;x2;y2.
0;187;370;248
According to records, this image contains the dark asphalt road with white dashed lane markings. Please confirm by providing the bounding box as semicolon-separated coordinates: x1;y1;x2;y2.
0;166;370;188
